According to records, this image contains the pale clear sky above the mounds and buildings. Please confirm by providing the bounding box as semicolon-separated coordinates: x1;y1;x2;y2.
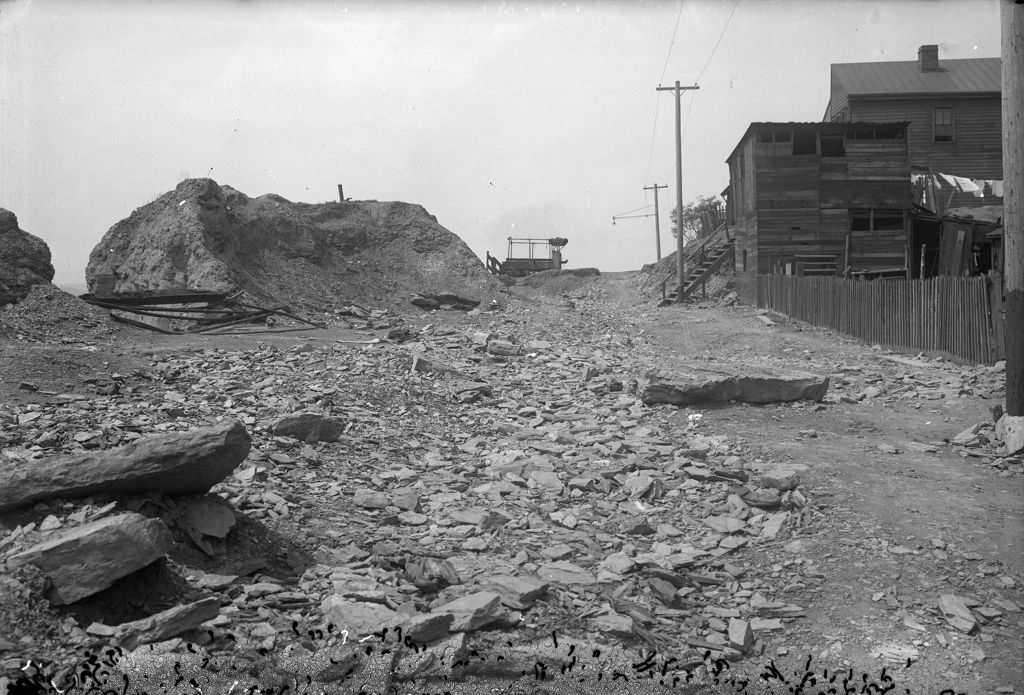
0;0;999;288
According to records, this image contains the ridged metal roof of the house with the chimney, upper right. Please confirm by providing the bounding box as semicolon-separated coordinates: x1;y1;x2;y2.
831;58;1001;96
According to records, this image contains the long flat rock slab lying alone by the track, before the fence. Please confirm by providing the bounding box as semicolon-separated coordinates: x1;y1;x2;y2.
639;364;828;405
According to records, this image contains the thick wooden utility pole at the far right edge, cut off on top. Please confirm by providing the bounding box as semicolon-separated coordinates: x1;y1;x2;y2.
999;0;1024;453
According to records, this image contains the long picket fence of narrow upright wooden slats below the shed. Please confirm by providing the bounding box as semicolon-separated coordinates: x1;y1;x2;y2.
758;275;1005;363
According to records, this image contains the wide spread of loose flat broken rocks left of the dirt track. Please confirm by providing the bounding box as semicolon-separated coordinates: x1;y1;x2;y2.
0;272;1018;695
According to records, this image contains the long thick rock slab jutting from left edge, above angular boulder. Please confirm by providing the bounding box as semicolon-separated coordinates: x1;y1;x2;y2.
0;421;251;511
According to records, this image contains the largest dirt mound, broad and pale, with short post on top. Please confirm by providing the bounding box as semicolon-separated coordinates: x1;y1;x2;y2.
86;179;502;309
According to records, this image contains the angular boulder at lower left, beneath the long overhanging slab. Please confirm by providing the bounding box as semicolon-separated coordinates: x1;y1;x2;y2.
8;513;174;606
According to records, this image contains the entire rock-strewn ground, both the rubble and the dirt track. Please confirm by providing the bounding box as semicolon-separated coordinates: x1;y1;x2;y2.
0;273;1024;693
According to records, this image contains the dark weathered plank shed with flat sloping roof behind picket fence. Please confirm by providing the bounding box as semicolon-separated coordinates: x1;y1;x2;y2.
726;122;912;297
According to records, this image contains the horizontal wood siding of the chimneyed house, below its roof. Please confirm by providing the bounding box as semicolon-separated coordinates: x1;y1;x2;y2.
849;94;1002;207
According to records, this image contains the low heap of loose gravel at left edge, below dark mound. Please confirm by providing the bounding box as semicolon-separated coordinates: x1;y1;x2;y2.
0;283;131;343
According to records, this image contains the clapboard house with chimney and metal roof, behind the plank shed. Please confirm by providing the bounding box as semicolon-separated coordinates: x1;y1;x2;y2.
823;45;1002;208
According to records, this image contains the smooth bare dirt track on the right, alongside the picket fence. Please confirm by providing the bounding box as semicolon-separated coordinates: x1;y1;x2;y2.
606;275;1024;692
